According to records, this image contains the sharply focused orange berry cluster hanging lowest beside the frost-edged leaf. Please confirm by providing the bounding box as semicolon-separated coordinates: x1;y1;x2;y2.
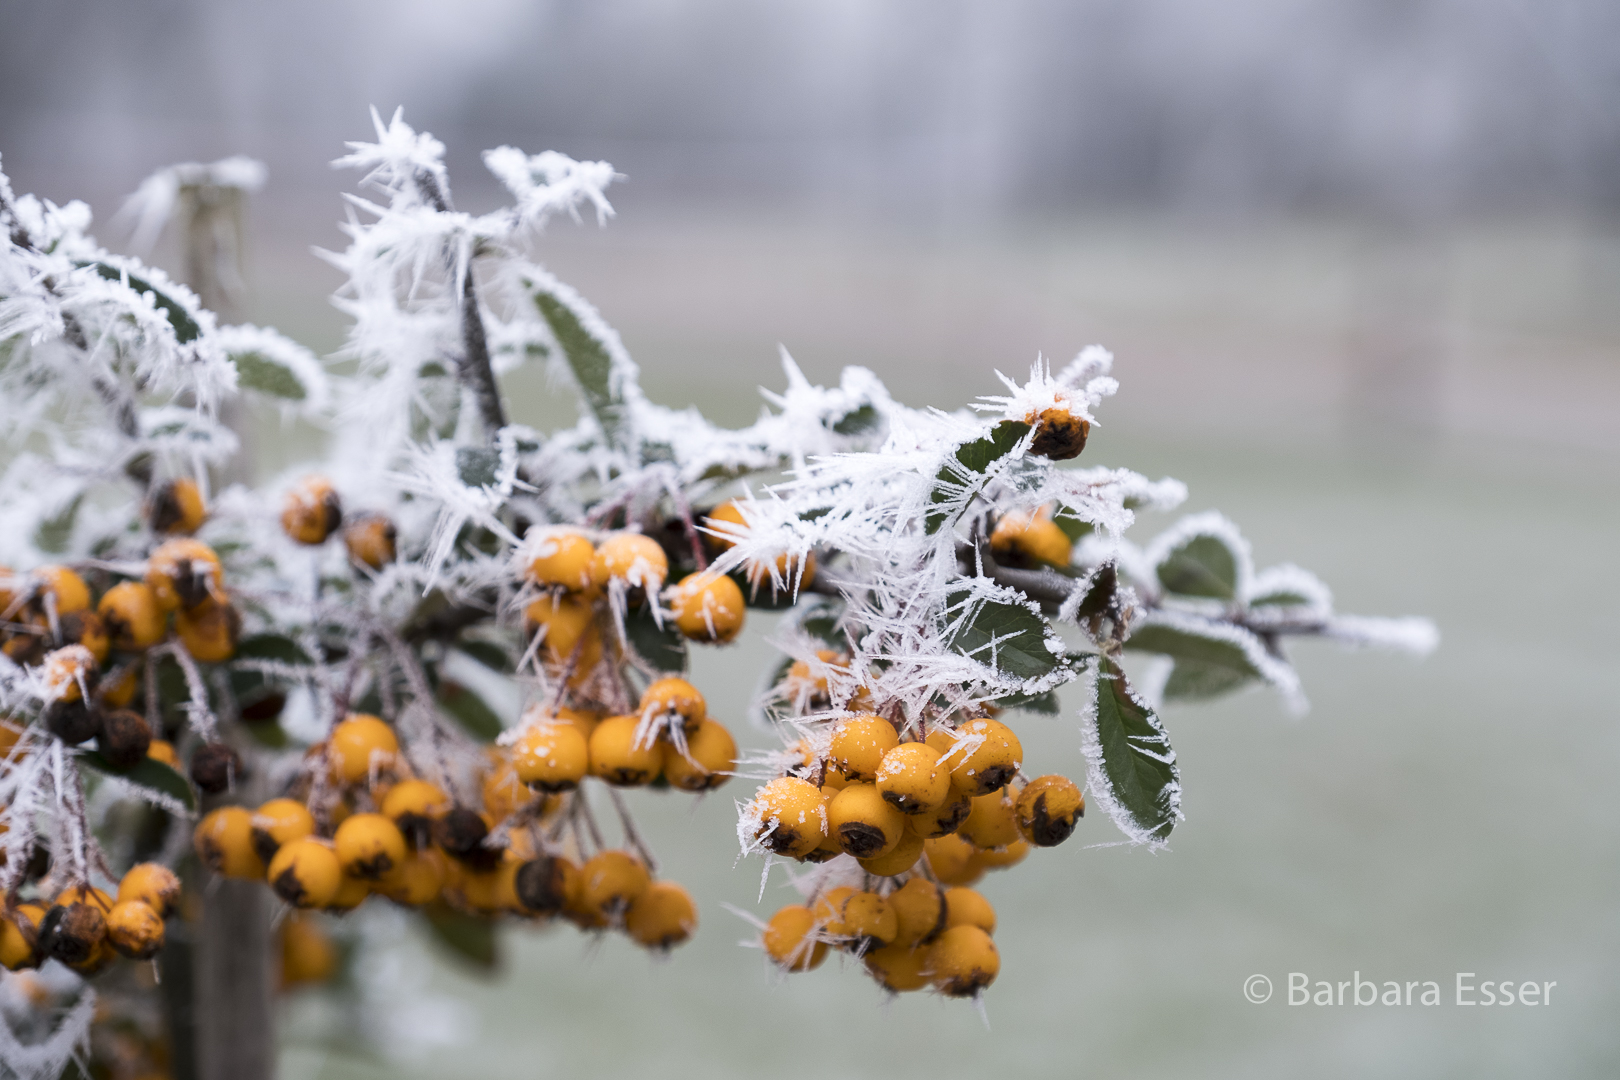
742;702;1085;996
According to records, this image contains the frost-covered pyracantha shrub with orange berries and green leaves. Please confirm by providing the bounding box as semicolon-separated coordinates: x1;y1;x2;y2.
0;105;1434;1068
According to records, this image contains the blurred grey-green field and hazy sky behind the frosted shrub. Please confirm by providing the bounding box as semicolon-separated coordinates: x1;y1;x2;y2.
0;0;1620;1080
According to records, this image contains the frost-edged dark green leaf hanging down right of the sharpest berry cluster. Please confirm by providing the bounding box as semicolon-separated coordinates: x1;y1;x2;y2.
1087;656;1181;844
